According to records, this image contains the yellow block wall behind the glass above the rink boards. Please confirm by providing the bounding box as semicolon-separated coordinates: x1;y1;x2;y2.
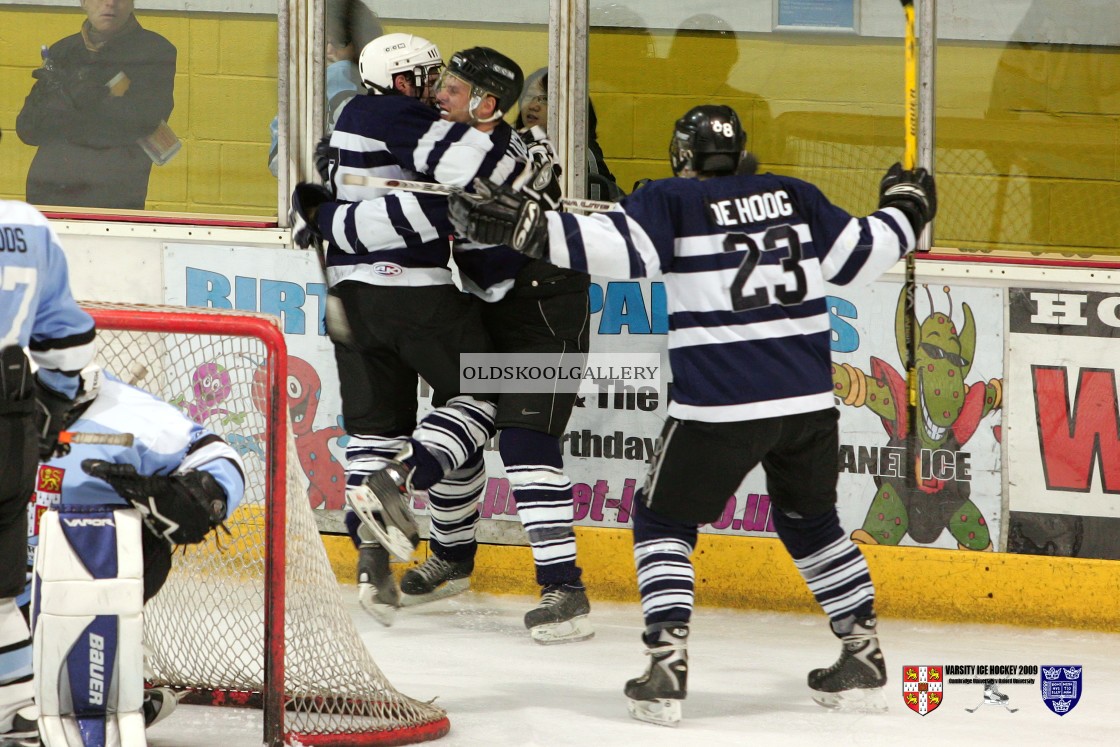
0;9;1120;254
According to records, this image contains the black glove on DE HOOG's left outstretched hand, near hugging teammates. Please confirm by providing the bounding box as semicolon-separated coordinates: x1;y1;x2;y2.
448;179;548;259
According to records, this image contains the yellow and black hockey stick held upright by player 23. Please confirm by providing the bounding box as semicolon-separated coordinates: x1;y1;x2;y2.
902;0;922;486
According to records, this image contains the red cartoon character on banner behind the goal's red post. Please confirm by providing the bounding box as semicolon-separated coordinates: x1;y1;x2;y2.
253;356;346;508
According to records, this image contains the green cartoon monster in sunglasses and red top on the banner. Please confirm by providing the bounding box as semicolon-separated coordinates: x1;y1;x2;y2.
832;287;1004;550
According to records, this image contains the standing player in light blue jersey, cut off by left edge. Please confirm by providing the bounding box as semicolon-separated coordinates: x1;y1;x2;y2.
0;195;94;747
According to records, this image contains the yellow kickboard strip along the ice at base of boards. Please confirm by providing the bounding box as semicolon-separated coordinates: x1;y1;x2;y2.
324;527;1120;632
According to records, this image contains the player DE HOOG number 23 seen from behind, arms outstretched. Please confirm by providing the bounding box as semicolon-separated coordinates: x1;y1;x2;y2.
450;105;936;726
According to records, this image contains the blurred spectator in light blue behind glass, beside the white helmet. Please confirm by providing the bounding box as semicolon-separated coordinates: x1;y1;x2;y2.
269;0;384;176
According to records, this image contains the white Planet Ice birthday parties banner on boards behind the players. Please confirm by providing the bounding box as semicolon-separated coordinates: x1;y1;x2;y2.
165;244;1004;550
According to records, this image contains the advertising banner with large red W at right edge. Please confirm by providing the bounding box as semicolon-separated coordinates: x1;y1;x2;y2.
1007;288;1120;559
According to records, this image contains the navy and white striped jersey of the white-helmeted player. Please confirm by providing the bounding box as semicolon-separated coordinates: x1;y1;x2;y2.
319;95;525;286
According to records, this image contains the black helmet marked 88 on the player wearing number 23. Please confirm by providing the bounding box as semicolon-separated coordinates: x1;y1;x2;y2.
669;104;747;177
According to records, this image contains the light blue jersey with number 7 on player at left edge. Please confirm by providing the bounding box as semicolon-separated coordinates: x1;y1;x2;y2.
0;200;94;398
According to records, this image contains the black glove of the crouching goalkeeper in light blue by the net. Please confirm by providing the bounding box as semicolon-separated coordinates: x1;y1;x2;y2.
82;459;226;544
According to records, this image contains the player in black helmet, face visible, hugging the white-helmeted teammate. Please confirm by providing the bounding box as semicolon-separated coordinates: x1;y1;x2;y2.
416;47;594;644
